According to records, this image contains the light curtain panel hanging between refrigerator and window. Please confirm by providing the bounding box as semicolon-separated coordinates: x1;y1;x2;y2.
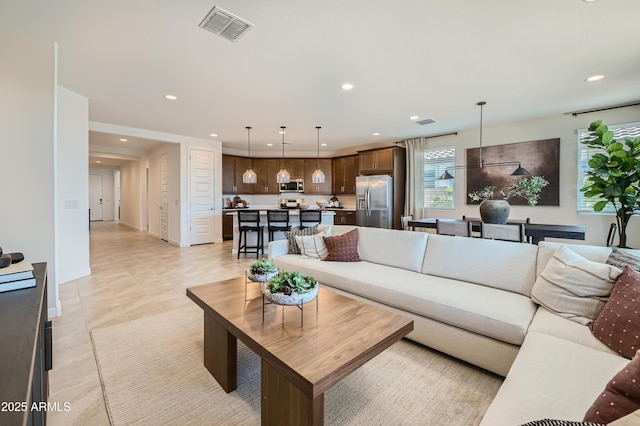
403;138;427;219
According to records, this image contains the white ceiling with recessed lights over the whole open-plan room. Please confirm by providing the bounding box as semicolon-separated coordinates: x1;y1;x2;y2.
0;0;640;160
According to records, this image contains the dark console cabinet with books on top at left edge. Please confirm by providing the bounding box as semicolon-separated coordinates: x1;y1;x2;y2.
0;263;53;426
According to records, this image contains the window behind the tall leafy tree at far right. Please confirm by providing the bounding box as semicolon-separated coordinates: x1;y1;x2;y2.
578;122;640;214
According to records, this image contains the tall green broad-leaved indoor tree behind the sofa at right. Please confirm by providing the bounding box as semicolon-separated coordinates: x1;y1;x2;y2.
580;120;640;247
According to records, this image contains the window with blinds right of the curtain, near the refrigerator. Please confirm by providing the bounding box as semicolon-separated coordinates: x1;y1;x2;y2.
424;147;456;210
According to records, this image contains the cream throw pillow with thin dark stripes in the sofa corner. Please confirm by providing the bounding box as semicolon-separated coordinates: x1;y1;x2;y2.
531;246;620;325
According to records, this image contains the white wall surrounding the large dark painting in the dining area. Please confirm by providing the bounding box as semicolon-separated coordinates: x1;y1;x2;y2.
426;107;640;247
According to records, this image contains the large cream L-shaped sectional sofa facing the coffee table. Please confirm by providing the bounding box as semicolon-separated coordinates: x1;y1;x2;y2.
268;225;640;426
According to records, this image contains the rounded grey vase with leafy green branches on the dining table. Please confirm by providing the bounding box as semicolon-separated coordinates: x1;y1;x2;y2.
469;176;549;224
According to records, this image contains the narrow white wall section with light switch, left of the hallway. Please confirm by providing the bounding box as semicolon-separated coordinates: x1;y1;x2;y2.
55;86;91;284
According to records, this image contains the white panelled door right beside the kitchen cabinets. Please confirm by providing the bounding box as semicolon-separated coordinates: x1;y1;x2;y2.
189;149;215;245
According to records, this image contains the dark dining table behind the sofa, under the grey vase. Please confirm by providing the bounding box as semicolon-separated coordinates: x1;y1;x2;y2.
407;217;587;244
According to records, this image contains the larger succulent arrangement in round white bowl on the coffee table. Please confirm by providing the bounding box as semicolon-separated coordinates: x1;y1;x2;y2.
264;271;320;305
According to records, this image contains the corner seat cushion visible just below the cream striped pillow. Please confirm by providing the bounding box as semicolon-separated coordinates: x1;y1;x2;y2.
527;306;618;355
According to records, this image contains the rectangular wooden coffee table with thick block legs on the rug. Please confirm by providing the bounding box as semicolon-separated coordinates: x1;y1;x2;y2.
187;277;413;425
